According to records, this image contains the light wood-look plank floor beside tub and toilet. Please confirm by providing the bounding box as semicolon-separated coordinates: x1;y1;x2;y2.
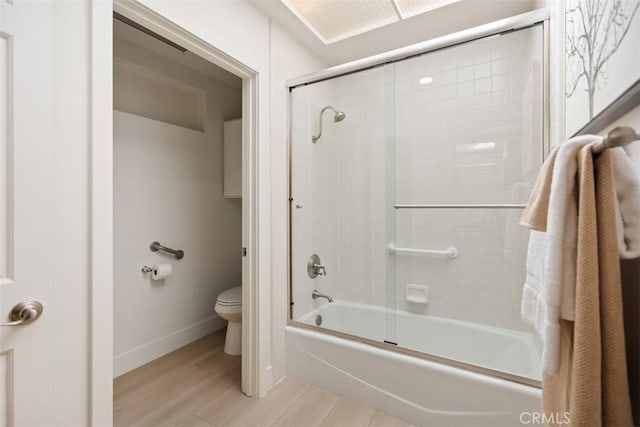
113;329;411;427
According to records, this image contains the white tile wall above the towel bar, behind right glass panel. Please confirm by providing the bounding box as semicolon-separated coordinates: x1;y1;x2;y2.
396;27;542;207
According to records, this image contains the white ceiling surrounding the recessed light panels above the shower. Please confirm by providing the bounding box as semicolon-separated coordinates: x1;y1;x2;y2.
249;0;541;66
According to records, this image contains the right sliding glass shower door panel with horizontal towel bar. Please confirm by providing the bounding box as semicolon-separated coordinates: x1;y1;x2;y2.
396;25;544;379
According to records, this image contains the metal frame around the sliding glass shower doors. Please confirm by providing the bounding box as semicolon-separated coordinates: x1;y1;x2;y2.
286;8;550;388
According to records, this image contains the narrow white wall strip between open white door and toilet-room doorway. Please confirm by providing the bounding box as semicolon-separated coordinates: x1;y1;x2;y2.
51;2;91;425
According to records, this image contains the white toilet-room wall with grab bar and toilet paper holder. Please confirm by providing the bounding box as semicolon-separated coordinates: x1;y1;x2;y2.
114;38;242;376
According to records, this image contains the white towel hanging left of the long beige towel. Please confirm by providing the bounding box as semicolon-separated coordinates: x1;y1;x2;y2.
521;135;602;373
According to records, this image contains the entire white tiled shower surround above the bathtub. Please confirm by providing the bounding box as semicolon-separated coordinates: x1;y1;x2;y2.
292;27;543;336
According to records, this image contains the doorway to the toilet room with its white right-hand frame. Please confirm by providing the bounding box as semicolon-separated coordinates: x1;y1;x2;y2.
113;3;259;418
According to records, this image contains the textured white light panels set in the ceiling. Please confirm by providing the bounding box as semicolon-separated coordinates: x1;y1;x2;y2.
281;0;459;44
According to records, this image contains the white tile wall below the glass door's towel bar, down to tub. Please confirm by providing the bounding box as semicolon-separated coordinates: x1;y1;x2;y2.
395;209;528;329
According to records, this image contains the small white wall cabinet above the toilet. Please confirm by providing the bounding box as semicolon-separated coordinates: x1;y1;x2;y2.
222;119;242;198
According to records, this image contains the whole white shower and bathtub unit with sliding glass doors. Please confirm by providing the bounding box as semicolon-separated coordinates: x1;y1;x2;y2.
286;10;548;426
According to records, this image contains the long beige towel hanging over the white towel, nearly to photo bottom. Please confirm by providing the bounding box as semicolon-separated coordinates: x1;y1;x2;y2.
542;146;632;426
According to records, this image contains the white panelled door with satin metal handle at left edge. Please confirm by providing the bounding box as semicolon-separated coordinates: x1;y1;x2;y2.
0;0;53;426
